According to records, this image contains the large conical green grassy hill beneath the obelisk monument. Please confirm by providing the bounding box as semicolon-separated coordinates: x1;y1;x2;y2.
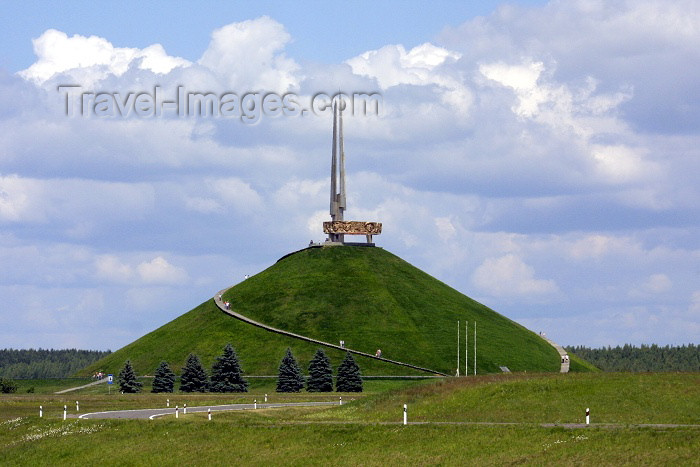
80;246;576;375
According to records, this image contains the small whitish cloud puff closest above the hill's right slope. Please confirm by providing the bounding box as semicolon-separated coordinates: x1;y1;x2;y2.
472;254;558;296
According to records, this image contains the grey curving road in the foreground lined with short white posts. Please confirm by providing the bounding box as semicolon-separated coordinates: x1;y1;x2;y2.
78;402;339;420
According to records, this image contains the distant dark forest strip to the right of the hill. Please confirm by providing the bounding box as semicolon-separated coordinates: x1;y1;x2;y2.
566;344;700;371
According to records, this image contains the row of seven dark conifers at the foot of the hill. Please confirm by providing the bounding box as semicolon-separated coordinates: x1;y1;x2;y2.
118;344;362;393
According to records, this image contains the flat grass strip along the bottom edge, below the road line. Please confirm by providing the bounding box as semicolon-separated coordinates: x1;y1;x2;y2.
0;417;700;466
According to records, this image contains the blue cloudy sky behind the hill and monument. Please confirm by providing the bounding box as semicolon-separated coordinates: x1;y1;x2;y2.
0;0;700;350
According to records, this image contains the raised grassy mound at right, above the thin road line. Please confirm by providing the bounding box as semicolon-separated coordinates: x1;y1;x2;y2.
309;373;700;425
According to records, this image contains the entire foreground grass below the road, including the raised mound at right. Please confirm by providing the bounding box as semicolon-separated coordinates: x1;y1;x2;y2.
0;373;700;466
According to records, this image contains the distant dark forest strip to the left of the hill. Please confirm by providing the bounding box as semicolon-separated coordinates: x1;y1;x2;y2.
0;349;112;379
